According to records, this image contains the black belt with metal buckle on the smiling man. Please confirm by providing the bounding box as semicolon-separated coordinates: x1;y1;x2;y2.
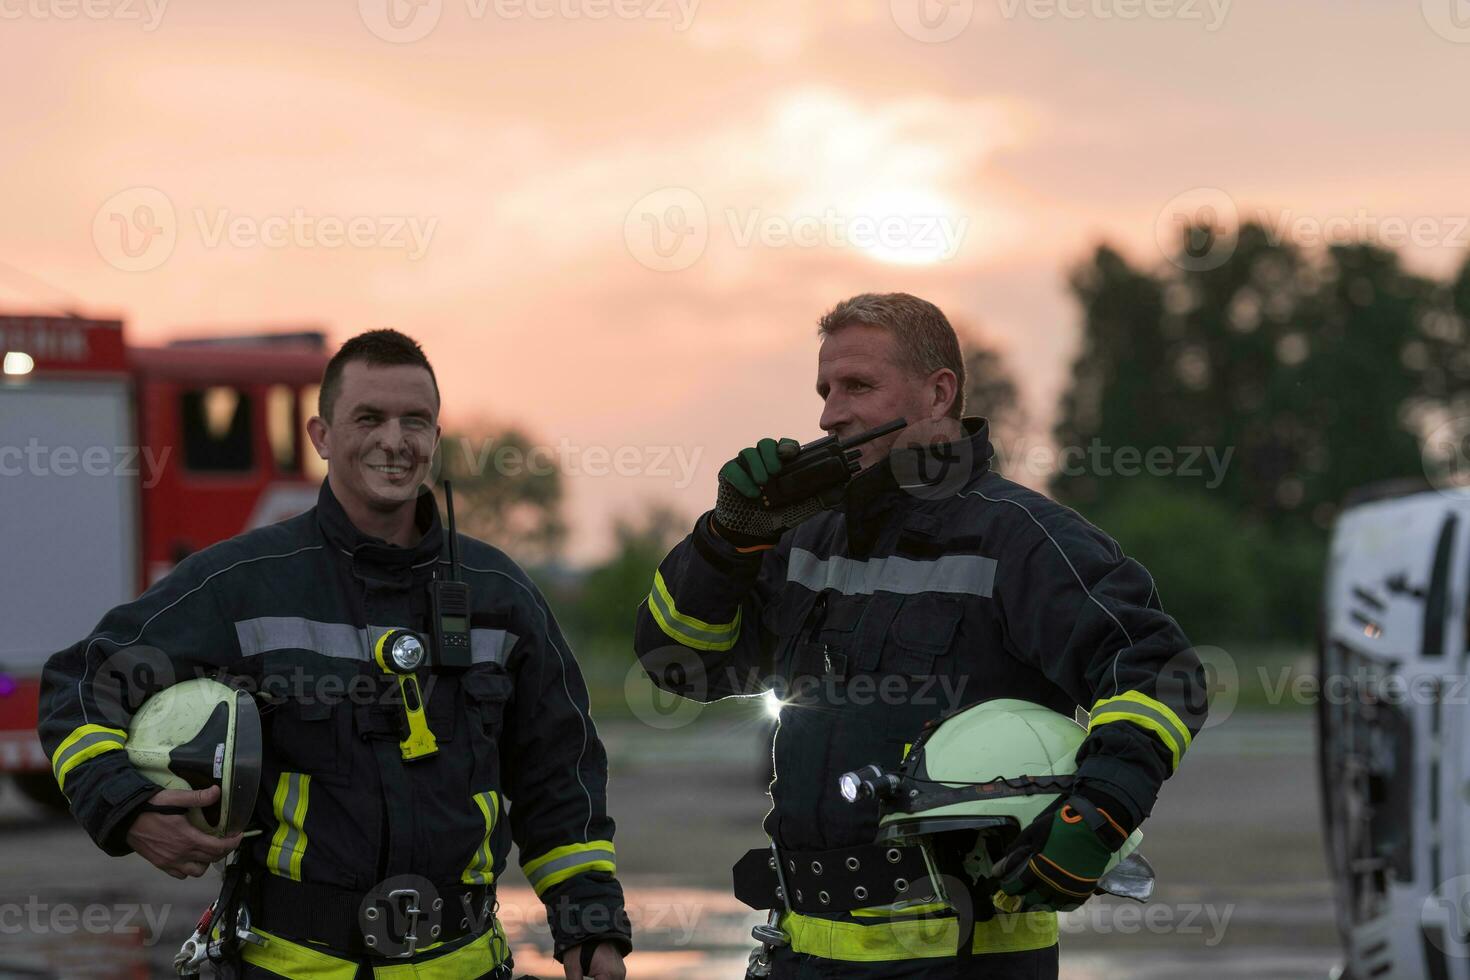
248;871;497;959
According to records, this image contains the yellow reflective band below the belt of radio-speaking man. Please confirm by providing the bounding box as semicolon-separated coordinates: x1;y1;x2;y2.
781;912;1058;962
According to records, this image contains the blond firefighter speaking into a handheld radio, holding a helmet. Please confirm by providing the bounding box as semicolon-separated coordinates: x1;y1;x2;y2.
635;294;1204;980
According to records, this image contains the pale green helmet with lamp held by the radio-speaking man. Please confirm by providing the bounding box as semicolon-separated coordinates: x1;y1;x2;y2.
841;698;1152;898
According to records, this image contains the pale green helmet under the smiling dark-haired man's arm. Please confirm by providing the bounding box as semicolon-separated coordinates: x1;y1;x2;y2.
128;677;262;837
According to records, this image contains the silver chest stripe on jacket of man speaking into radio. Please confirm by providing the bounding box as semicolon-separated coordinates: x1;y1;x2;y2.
786;548;995;597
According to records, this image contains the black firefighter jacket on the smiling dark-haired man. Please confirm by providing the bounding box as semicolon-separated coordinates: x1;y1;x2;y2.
40;480;629;955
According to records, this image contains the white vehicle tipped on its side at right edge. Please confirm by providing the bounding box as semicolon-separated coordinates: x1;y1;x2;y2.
1319;483;1470;980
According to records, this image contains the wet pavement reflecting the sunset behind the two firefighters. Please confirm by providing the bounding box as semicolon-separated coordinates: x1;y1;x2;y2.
0;704;1338;980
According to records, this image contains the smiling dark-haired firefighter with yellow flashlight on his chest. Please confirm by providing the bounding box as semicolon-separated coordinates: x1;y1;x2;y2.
40;331;631;980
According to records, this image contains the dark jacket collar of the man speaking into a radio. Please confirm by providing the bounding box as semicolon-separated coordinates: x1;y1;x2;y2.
842;416;994;523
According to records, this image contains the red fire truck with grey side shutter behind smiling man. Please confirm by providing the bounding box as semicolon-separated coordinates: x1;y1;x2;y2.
0;314;328;804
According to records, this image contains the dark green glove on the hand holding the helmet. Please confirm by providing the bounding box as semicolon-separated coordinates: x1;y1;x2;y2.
991;790;1129;912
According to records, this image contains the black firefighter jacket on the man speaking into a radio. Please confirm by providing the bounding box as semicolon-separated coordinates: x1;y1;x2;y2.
637;419;1205;851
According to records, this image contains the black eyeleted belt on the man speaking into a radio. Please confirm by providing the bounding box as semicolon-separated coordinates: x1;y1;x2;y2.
732;843;935;915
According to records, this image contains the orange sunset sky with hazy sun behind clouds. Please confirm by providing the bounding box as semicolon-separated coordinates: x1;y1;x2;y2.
0;0;1470;561
